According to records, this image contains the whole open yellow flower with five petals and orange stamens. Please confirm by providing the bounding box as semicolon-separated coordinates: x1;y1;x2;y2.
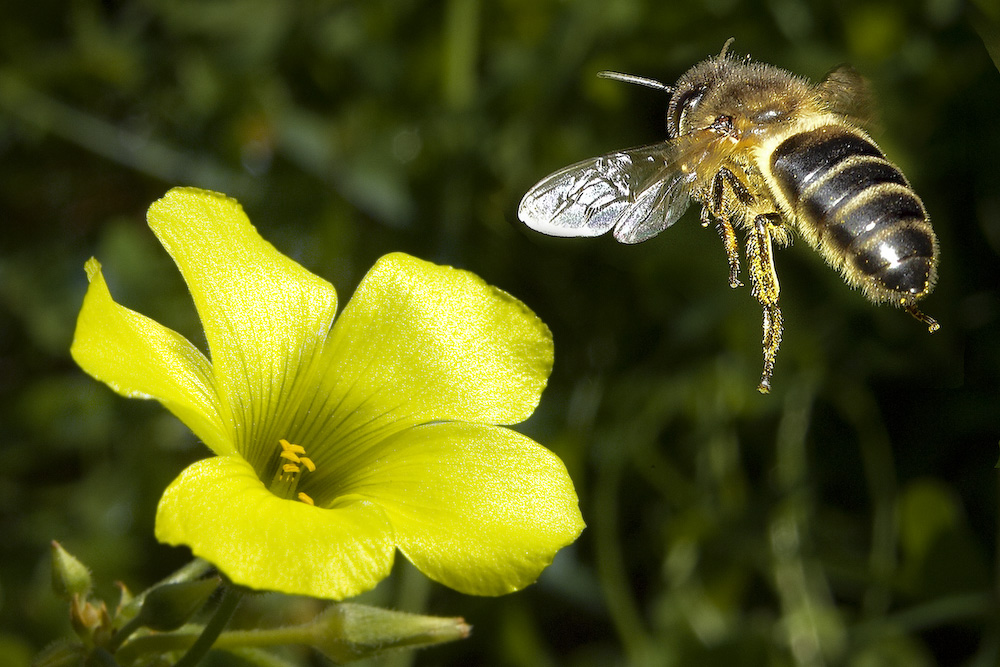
72;188;583;599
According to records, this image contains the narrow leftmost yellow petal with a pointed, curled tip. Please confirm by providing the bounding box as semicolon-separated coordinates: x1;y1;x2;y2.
70;259;234;454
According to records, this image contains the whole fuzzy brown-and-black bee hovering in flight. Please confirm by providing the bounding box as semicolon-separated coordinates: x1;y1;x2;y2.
518;39;938;393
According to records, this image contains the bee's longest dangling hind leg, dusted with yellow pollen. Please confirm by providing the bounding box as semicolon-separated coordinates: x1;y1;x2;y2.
747;214;781;394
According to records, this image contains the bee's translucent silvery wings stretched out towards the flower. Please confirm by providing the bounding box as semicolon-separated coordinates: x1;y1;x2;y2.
517;142;688;243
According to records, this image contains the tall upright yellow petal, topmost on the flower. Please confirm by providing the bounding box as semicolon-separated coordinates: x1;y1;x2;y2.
148;188;337;472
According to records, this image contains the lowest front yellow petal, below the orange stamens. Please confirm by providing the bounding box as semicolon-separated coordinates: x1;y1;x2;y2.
156;456;395;600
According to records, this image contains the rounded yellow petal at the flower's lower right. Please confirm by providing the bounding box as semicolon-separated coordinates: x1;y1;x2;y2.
330;423;584;595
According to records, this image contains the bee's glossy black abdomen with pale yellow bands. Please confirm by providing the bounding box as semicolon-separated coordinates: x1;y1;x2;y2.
770;125;937;303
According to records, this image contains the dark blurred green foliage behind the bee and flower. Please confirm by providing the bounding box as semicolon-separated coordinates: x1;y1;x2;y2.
0;0;1000;667
